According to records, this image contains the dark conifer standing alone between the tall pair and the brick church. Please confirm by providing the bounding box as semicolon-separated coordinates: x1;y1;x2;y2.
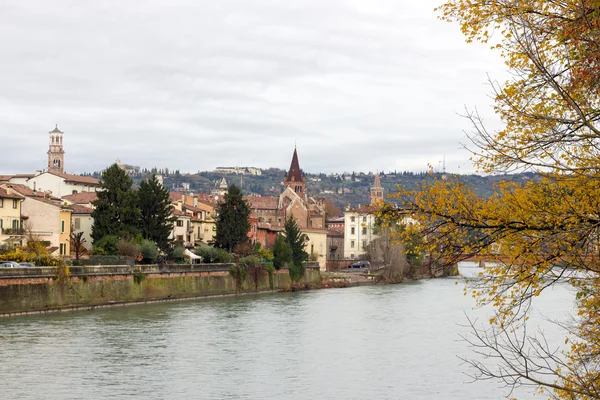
215;185;250;251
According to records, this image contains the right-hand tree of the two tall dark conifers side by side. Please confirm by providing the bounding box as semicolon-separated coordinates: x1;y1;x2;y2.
138;175;176;252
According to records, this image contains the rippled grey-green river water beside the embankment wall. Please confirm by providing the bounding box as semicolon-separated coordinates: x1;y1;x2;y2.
0;264;572;400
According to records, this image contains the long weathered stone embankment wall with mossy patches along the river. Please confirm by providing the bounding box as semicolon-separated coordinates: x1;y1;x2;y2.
0;264;321;316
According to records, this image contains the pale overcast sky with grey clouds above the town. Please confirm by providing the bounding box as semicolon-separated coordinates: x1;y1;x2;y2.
0;0;507;175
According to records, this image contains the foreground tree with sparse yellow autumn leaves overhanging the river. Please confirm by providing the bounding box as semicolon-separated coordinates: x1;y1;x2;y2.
381;0;600;399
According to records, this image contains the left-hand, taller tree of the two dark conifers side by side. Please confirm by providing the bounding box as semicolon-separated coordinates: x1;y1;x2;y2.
92;164;140;242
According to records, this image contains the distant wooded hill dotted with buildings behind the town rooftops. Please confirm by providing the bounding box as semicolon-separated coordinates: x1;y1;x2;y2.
89;168;538;212
